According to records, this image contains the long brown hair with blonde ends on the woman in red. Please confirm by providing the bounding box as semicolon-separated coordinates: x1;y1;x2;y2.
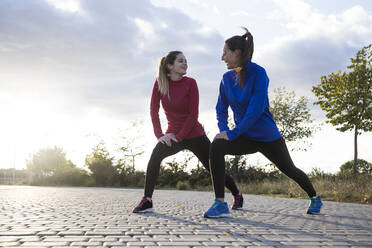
157;51;182;96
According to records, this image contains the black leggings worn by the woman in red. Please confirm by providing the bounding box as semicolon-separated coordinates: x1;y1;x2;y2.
145;135;239;197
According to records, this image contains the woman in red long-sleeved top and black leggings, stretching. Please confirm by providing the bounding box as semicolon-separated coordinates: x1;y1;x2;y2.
133;51;243;213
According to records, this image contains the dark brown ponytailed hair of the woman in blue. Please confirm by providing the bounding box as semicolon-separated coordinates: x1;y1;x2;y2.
225;27;254;87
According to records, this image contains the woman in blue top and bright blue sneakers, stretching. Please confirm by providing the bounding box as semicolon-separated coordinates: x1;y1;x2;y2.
204;28;322;218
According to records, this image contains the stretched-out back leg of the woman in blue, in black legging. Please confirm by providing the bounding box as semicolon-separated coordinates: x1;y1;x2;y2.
259;138;316;197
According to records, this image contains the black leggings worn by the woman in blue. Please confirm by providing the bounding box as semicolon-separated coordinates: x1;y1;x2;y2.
210;136;316;198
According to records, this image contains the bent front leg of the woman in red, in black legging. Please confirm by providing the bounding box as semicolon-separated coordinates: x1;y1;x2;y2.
145;142;184;198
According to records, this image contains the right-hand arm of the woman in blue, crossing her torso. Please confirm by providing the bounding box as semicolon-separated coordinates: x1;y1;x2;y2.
227;69;269;140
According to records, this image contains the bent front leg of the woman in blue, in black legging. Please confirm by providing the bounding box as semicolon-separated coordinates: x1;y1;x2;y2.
209;137;257;199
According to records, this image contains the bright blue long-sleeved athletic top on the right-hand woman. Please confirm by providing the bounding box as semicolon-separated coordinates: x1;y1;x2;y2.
216;61;281;142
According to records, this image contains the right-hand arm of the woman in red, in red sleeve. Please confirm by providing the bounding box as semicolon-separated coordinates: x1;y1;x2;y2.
176;80;199;141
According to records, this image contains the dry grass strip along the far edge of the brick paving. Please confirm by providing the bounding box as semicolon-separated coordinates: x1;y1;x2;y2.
21;172;372;204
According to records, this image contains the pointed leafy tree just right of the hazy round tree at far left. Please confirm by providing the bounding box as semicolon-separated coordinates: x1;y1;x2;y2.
85;141;116;186
